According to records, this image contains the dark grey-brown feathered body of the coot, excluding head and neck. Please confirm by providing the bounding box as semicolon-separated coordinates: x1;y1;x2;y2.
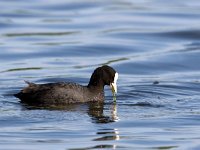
15;82;104;105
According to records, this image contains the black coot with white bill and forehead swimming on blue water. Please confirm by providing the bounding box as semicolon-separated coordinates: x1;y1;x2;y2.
14;65;118;105
